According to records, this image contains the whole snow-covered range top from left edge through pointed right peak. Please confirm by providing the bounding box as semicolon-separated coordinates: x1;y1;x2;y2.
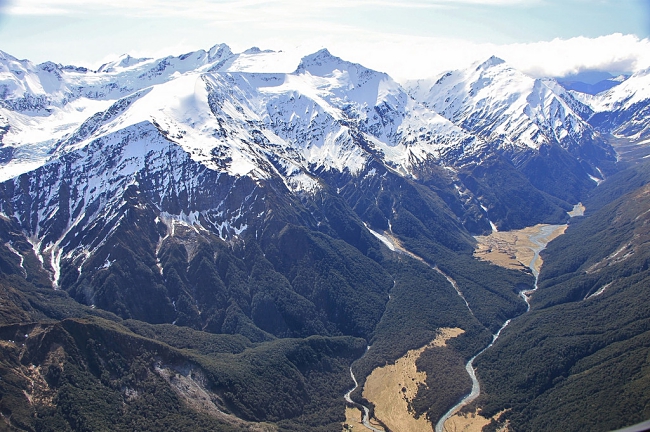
0;44;616;190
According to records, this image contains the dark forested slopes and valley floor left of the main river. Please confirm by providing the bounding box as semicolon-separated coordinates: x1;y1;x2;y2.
0;156;532;431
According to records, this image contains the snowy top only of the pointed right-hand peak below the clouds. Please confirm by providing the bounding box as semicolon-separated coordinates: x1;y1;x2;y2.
410;57;595;159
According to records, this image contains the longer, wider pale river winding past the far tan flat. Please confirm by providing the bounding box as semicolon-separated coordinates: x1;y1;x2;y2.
435;225;561;432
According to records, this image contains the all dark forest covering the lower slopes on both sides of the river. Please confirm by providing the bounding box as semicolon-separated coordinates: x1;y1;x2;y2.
0;143;650;431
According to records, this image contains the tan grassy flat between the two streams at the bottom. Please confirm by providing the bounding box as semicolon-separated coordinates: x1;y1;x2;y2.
363;328;464;432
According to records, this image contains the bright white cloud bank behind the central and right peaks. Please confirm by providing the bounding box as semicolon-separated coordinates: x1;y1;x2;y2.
274;28;650;80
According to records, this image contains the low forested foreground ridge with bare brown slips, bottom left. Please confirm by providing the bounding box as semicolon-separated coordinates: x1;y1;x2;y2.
0;319;365;431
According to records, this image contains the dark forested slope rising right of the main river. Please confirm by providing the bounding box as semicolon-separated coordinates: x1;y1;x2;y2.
468;164;650;431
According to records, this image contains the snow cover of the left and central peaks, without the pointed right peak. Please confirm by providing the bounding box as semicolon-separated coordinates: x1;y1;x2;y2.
0;45;482;185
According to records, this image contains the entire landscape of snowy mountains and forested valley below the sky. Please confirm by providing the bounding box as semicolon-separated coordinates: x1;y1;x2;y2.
0;45;650;432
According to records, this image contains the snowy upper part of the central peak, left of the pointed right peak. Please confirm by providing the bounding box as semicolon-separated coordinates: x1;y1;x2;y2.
205;50;484;175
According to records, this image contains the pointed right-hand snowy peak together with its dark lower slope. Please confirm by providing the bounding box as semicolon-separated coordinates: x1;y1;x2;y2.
410;57;614;202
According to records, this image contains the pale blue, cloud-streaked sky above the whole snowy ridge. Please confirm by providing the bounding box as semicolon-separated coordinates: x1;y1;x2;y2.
0;0;650;78
